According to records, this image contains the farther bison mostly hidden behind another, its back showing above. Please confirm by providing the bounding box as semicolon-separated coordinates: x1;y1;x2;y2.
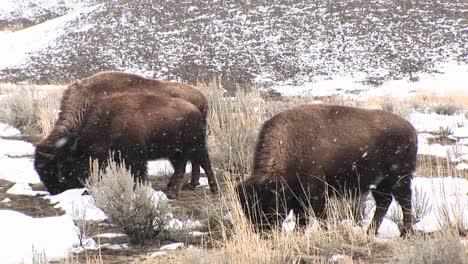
46;71;208;189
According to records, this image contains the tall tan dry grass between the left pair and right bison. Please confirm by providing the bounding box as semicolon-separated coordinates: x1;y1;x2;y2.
199;80;265;174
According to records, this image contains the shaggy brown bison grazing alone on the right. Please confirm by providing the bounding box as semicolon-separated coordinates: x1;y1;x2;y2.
236;105;417;235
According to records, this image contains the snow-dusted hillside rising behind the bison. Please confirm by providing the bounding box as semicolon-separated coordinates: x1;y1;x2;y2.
0;0;468;89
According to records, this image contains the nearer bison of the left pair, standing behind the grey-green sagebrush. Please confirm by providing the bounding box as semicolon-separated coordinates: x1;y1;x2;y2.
34;93;217;198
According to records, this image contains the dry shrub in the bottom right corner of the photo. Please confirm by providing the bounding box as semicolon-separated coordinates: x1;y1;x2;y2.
390;229;468;264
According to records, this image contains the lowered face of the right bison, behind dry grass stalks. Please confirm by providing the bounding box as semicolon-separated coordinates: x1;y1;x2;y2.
236;179;288;229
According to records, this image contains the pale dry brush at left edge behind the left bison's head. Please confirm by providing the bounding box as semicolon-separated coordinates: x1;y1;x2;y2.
0;85;61;136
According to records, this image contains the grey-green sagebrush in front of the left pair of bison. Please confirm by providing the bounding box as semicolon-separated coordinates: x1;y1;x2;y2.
85;157;168;245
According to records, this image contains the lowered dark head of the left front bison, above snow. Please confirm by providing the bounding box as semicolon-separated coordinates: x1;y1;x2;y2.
34;139;88;194
